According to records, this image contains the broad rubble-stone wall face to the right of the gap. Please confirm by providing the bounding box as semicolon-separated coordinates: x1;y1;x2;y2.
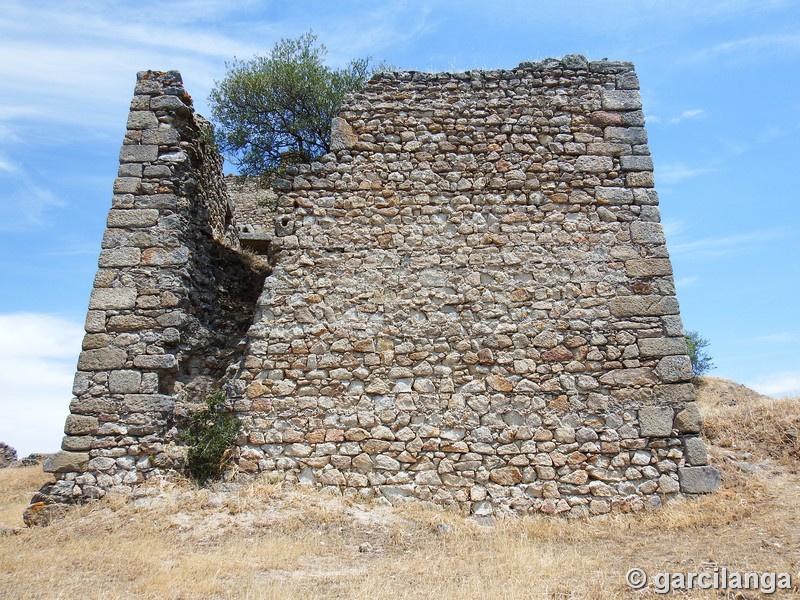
228;56;718;515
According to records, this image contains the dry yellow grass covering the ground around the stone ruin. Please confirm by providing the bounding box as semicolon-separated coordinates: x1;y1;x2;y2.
0;384;800;600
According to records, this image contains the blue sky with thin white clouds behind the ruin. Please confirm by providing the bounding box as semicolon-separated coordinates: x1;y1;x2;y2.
0;0;800;454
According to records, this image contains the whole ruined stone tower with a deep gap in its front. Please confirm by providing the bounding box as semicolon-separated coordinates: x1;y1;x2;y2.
40;56;718;515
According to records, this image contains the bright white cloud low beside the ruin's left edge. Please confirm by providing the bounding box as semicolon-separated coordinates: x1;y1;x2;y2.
0;313;83;456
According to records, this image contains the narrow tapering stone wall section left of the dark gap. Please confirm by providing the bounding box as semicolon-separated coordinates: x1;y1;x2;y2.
34;71;266;502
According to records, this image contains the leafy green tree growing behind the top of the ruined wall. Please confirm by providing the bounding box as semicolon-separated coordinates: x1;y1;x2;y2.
209;32;375;183
